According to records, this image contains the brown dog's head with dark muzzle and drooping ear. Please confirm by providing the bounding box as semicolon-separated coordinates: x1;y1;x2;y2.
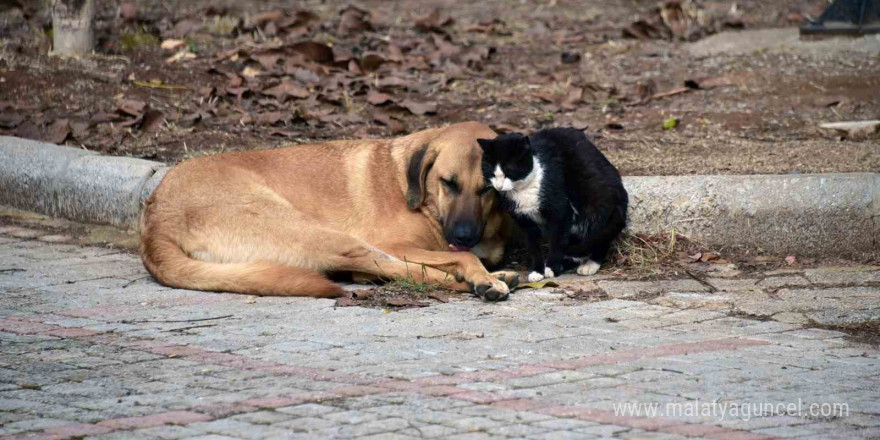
406;122;496;251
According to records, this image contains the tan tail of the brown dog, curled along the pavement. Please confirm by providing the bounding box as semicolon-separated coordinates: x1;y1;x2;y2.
141;234;343;298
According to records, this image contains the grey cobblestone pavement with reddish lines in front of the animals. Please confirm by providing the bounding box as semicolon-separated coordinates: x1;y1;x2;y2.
0;227;880;440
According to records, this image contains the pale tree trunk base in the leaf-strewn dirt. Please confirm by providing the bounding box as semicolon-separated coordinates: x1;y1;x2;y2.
52;0;95;56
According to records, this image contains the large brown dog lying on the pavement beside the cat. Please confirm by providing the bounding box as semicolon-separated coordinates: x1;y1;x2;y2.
141;122;518;300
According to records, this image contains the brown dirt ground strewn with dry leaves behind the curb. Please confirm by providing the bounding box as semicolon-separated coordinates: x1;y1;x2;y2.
0;0;880;175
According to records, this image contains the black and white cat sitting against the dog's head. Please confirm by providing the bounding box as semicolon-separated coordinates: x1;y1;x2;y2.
477;128;629;282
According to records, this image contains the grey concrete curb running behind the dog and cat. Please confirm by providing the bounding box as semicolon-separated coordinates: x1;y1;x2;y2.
0;136;880;259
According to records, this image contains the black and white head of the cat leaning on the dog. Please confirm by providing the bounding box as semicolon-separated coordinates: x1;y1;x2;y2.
477;133;534;192
